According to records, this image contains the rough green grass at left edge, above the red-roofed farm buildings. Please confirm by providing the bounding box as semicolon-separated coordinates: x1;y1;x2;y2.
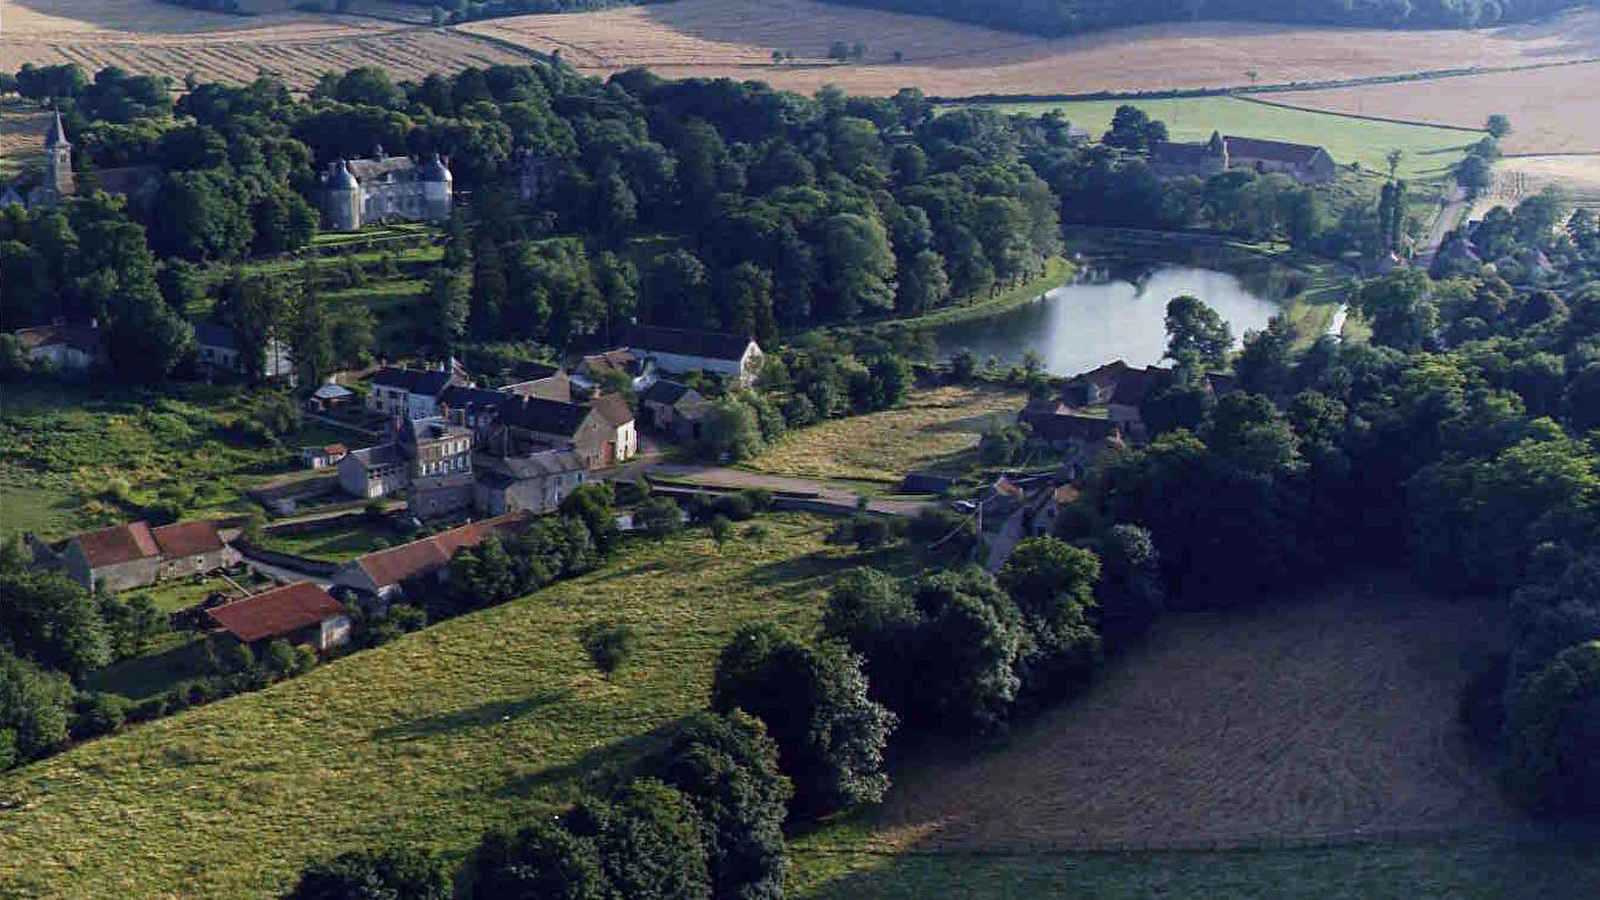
0;377;347;536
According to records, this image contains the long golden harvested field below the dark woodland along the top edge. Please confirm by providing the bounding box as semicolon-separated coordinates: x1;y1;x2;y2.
462;0;1600;96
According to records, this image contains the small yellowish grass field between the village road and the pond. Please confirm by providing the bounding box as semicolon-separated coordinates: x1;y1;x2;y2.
746;386;1026;482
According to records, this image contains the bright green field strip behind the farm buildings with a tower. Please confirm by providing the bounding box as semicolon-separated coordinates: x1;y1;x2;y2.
997;94;1482;178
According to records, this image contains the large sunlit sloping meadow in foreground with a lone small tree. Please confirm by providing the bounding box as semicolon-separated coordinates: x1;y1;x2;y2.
0;516;906;900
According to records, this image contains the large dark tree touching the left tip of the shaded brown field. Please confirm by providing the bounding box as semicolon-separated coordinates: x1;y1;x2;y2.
710;625;896;818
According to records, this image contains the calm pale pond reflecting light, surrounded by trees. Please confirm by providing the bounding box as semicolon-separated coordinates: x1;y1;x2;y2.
938;266;1278;375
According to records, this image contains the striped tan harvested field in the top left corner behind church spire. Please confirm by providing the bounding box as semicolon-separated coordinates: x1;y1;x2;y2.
0;0;530;86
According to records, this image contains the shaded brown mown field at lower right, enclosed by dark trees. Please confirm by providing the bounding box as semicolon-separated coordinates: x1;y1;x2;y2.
872;580;1517;850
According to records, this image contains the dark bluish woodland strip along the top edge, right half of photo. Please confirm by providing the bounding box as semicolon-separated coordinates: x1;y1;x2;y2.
812;0;1579;37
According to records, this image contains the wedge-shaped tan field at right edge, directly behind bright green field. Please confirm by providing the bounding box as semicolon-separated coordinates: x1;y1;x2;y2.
1272;62;1600;154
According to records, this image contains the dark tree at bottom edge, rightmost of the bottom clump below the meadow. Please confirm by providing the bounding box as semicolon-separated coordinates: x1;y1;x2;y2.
650;711;794;900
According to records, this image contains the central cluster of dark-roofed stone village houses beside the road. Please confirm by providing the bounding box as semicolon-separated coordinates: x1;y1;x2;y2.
328;327;763;517
